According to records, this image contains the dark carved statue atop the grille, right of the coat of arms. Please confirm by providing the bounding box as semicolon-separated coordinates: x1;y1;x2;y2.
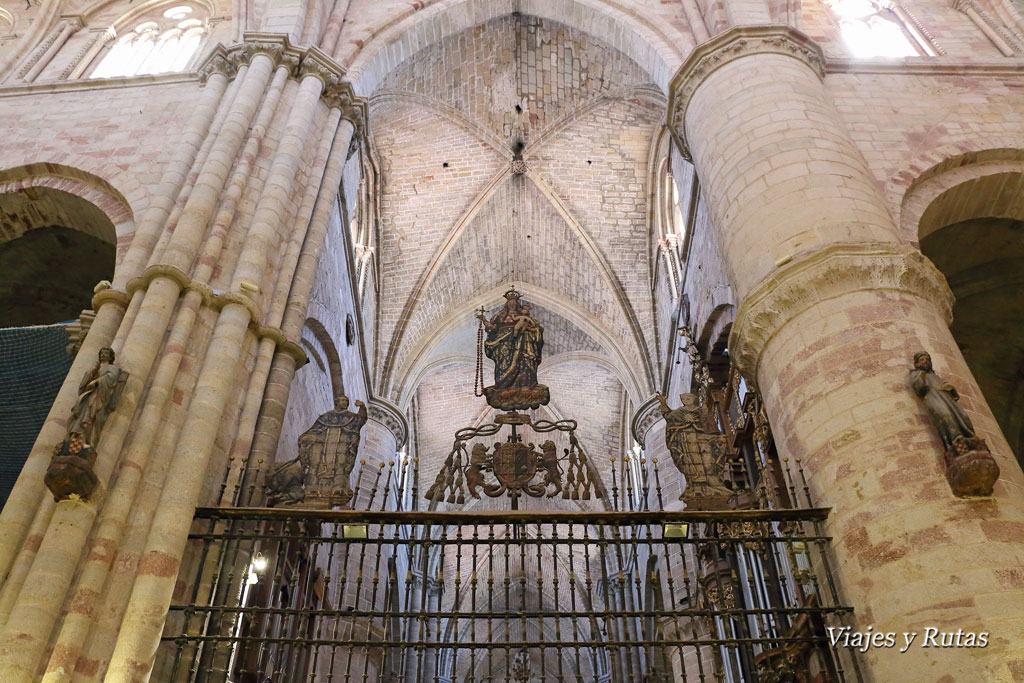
657;393;733;510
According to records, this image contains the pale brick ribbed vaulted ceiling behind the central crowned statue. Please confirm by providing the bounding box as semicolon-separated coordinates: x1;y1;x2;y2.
371;10;665;409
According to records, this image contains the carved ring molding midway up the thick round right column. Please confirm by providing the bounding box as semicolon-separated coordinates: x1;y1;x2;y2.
729;242;953;384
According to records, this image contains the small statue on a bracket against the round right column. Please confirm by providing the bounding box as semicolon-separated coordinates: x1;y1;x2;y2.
910;351;999;498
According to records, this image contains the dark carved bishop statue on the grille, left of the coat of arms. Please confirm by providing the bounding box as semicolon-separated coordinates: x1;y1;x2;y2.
266;396;367;508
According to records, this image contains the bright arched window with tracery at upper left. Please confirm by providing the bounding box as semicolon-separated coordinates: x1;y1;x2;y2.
90;5;207;78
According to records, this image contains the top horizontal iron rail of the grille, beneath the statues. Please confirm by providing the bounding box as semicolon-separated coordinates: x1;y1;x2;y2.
195;507;831;526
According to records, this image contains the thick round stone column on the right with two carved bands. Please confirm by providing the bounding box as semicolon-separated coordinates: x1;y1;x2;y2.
670;27;1024;680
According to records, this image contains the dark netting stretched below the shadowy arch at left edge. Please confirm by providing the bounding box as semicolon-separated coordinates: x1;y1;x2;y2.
0;324;71;504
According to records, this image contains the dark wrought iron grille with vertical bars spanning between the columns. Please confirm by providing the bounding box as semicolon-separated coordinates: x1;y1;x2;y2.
161;508;860;683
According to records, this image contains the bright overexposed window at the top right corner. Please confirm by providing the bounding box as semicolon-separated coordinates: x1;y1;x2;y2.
826;0;935;57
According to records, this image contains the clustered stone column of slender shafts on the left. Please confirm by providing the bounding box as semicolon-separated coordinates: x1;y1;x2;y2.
0;34;366;682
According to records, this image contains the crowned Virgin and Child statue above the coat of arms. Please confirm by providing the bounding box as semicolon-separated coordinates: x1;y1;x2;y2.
476;287;549;411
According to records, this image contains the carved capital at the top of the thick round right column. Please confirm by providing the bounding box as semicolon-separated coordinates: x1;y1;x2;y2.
668;26;825;159
